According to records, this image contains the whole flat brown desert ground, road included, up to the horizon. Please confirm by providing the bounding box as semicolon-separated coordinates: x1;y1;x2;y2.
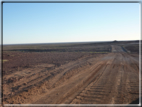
2;41;141;104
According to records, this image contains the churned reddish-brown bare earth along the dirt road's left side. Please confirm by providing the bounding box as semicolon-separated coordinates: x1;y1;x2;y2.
3;53;101;103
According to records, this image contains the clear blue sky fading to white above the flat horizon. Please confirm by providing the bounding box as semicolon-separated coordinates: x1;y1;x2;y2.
3;3;140;44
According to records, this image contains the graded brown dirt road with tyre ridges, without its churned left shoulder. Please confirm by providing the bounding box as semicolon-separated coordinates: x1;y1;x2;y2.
35;46;139;104
